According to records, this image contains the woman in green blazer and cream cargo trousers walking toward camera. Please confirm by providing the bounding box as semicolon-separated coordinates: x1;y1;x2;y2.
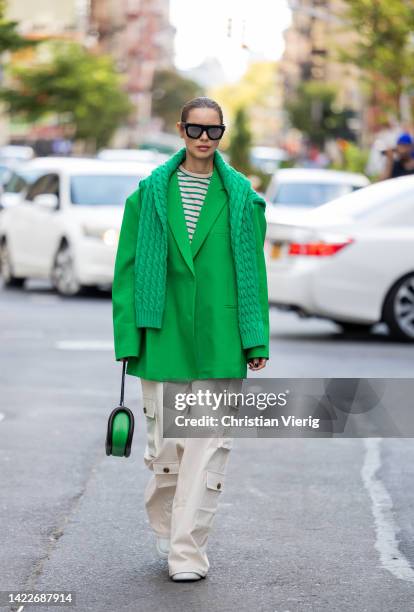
112;97;269;581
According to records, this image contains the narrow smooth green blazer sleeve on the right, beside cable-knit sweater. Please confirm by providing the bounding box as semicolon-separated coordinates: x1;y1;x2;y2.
245;196;269;359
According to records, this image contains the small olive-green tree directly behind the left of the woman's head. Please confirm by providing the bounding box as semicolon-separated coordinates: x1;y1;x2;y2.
152;70;205;133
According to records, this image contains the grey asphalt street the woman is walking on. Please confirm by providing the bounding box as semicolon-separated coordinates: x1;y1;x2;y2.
0;283;414;612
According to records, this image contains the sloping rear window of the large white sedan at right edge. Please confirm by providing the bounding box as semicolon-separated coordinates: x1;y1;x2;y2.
309;178;414;220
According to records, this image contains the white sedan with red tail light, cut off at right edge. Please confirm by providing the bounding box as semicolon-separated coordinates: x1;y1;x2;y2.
265;176;414;341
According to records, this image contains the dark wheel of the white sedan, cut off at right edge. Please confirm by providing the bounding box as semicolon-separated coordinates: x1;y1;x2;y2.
383;273;414;342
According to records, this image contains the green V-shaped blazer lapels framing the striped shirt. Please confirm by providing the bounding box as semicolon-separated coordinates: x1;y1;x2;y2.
167;166;227;275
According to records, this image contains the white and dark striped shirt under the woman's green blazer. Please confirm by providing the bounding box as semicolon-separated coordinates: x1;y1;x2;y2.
177;164;213;242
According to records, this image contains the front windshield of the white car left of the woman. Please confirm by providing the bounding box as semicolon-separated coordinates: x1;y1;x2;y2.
70;174;143;206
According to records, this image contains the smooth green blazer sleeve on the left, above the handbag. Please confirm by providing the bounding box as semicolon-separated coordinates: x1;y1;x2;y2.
112;189;142;361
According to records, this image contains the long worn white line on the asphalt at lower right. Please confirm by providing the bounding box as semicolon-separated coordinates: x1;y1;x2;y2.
361;438;414;582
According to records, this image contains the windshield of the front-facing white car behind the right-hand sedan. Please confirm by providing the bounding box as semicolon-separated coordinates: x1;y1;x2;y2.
272;181;358;208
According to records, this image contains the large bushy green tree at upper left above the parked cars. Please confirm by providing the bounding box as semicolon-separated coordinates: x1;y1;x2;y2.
0;41;132;148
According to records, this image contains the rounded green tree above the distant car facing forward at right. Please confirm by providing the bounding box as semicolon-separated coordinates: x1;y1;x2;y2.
286;81;352;147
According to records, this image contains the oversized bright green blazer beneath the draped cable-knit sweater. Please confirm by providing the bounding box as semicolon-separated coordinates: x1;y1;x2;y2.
112;166;269;381
